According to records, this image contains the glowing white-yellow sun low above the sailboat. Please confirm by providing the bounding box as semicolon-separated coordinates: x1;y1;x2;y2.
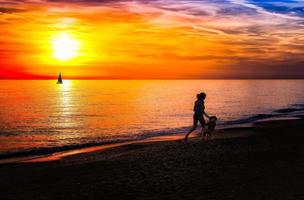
52;33;80;60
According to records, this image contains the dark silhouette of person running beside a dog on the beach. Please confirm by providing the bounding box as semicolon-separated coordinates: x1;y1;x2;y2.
185;92;210;142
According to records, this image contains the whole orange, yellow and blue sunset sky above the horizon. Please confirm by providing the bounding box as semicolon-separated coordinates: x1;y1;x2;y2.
0;0;304;79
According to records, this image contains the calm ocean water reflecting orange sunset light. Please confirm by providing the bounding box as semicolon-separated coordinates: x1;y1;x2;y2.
0;80;304;158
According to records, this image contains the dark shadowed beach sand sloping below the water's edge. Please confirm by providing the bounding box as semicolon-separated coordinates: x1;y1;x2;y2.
0;119;304;200
